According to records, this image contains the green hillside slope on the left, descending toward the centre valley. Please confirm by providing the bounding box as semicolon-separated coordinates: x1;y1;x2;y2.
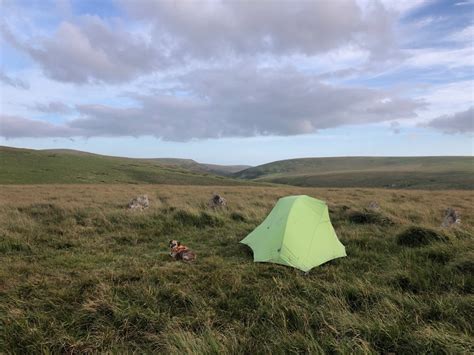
0;147;252;185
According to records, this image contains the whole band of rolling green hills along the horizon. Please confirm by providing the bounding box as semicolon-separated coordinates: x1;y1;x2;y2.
0;147;474;189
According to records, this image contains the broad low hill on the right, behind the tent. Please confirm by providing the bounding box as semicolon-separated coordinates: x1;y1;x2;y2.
234;157;474;189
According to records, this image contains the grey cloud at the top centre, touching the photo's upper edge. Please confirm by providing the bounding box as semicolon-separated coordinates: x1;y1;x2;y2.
122;0;394;59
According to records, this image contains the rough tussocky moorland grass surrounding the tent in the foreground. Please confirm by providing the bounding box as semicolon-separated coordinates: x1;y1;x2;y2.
0;184;474;354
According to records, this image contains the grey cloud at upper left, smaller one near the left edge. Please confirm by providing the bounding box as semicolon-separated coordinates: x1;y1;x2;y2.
2;16;162;83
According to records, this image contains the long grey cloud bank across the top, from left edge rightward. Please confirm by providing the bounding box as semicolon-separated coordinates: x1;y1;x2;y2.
2;0;397;84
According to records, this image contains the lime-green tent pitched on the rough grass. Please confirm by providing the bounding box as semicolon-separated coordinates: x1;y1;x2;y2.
241;195;346;271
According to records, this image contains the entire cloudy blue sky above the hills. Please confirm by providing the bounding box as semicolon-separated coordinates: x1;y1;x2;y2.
0;0;474;165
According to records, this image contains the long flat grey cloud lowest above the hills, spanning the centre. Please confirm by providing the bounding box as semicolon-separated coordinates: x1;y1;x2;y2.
0;68;424;141
